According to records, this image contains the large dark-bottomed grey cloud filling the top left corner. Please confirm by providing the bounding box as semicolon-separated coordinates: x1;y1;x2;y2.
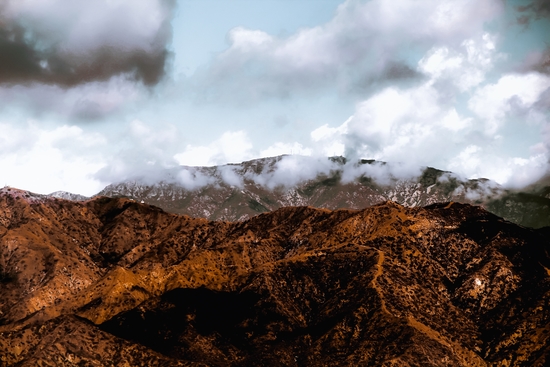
0;0;175;87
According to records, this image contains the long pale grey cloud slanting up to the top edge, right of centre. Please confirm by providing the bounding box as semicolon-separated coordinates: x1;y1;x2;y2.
191;0;502;104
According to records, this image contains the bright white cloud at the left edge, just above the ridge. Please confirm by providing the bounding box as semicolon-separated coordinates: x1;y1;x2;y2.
0;121;107;195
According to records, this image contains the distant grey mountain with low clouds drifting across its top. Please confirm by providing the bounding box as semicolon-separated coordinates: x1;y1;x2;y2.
98;156;550;228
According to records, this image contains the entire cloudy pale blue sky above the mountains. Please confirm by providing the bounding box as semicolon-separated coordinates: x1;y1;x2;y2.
0;0;550;195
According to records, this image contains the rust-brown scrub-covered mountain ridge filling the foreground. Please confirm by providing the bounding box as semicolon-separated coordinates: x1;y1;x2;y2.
0;189;550;366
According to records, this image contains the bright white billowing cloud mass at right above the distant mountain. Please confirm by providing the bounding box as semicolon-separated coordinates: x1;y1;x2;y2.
302;27;550;187
